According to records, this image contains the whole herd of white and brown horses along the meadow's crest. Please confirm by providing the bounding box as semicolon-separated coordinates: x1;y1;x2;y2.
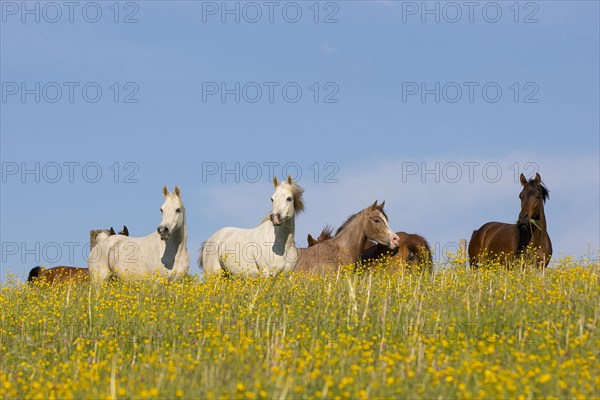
28;174;552;284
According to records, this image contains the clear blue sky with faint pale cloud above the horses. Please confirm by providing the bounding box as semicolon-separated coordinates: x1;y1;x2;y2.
0;1;600;277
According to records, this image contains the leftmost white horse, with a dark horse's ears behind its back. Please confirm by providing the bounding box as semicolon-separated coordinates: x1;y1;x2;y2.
88;186;190;283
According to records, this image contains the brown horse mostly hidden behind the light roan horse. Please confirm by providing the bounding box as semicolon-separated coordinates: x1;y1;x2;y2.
307;226;433;269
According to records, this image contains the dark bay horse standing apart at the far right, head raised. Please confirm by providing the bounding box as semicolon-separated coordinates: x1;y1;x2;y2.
469;174;552;267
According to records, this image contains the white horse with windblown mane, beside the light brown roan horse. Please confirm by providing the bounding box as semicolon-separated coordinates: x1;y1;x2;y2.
198;176;304;276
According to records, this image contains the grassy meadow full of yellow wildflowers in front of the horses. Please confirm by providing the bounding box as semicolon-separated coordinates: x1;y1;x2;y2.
0;260;600;399
